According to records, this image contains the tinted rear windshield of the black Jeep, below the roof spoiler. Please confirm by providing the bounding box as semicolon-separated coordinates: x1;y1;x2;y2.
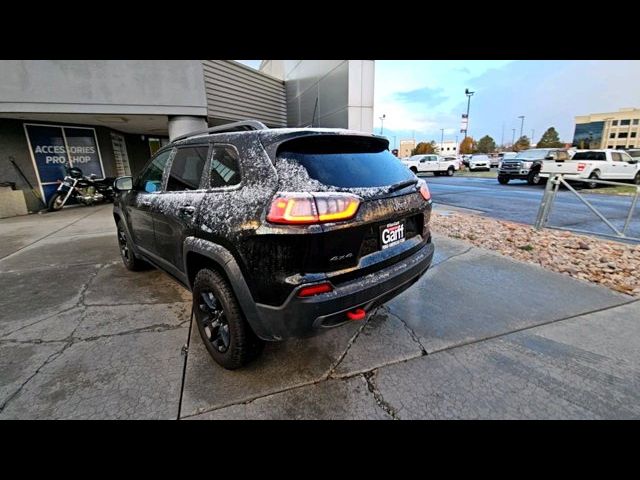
277;135;414;188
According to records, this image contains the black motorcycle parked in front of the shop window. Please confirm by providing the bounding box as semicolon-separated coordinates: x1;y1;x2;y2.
48;167;114;212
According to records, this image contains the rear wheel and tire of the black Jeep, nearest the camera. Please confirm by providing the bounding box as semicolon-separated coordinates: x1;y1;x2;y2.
193;268;264;370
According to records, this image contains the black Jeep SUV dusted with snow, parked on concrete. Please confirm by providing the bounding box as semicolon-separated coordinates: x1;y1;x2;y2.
113;121;434;369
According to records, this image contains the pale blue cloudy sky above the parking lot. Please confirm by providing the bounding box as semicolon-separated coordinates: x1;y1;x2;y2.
236;60;640;146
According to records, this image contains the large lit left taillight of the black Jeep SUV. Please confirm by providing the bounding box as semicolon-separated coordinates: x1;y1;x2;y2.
267;193;360;225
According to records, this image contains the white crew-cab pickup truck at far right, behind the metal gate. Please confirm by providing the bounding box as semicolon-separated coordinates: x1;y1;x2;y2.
540;149;640;188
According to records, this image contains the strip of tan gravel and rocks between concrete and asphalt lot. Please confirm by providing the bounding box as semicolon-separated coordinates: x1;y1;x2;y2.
431;212;640;296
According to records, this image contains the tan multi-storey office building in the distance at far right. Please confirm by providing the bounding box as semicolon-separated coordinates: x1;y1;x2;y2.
573;108;640;150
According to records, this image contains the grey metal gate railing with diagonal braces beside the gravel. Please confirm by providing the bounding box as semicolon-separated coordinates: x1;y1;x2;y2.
534;173;640;242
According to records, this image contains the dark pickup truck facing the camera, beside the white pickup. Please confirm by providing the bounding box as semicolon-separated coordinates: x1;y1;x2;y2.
498;148;569;185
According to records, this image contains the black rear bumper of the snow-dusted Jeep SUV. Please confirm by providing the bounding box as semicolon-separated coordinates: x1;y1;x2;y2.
250;243;434;340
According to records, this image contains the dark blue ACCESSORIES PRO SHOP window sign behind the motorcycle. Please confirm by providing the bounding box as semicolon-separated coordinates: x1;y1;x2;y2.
24;123;104;202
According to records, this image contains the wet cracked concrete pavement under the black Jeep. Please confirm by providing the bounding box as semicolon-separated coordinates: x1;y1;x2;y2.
0;205;640;419
